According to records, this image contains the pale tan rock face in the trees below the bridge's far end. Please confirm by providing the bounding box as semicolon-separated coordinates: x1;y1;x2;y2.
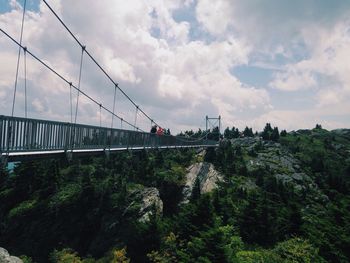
182;162;223;203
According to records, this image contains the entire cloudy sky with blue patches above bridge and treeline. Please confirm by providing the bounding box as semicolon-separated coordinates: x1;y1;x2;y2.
0;0;350;132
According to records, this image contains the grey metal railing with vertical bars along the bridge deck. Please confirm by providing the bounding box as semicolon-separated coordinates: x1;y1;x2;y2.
0;115;217;154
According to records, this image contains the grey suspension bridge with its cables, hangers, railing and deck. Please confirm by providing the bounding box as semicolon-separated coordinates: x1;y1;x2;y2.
0;0;218;161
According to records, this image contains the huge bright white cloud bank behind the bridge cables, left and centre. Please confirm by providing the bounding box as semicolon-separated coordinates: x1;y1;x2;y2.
0;0;269;130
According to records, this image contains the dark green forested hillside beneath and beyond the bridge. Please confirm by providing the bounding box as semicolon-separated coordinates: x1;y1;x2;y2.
0;124;350;262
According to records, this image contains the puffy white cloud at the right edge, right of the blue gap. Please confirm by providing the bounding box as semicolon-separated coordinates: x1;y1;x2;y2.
270;21;350;106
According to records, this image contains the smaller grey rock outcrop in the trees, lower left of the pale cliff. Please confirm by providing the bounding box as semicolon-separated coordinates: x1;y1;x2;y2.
124;187;163;222
